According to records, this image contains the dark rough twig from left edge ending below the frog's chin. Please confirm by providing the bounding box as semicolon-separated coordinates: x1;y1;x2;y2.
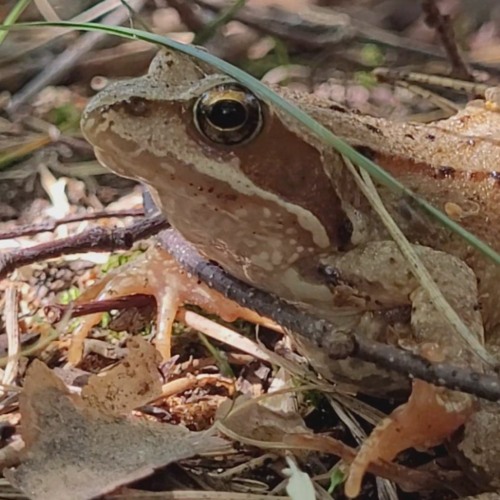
0;216;168;279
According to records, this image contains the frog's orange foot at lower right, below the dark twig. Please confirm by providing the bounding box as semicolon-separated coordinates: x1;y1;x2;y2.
345;380;472;498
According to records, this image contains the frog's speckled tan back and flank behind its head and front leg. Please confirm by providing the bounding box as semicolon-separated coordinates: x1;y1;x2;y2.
294;91;500;330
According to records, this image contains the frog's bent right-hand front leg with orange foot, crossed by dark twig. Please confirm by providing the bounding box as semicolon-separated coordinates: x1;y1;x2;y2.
320;241;483;497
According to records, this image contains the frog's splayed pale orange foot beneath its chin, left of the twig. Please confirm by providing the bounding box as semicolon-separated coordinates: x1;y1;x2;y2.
68;246;270;365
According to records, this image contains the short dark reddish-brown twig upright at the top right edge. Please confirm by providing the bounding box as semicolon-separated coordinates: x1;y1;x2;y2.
422;0;474;81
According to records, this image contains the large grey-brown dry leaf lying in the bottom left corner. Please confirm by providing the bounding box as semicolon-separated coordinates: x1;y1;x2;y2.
4;354;226;500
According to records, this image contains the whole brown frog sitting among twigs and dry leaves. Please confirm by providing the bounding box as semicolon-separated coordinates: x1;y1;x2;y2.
79;51;500;496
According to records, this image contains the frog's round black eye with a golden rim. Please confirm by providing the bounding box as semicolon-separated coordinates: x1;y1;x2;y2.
193;83;262;145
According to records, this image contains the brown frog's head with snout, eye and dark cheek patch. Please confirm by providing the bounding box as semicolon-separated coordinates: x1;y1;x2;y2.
82;50;351;302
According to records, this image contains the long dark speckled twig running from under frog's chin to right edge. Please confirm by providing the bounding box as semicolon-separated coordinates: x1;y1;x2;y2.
159;230;500;401
